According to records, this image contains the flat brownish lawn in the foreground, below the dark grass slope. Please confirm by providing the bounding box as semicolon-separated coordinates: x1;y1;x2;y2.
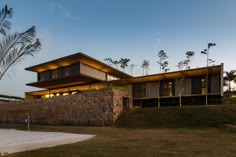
6;126;236;157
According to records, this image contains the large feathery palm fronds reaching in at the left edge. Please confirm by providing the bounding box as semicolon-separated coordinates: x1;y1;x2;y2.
0;5;41;80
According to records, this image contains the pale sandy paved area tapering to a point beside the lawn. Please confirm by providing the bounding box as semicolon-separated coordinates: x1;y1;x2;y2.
0;129;95;155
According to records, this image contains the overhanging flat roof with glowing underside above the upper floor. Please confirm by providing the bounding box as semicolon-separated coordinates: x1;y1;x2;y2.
25;52;132;78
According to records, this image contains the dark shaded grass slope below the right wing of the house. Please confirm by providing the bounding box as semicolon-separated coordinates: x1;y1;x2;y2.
116;105;236;128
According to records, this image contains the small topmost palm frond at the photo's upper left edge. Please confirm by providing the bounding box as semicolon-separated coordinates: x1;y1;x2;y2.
0;5;12;36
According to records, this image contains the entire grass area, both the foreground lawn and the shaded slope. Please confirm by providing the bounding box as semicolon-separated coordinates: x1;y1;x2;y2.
5;106;236;157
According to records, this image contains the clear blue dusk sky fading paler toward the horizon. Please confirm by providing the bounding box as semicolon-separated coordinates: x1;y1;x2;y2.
0;0;236;96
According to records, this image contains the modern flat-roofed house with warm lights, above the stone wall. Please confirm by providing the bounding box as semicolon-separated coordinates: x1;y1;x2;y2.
26;52;223;107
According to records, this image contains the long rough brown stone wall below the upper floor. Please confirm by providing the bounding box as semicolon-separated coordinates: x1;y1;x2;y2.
0;89;132;126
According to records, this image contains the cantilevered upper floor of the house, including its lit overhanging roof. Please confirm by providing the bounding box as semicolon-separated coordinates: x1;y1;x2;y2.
26;52;132;89
